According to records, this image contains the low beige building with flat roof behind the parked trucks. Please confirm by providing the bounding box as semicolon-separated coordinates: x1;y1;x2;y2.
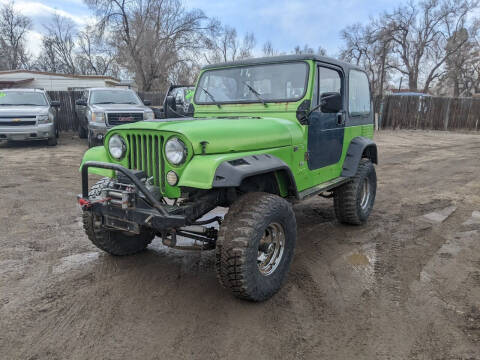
0;70;137;91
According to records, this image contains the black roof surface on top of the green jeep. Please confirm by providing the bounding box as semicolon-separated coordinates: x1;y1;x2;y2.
203;54;363;71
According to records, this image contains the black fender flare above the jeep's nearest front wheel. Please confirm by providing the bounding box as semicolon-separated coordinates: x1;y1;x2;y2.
212;154;297;195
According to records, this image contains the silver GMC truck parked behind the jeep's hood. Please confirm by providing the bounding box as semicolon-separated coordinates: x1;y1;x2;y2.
75;88;155;147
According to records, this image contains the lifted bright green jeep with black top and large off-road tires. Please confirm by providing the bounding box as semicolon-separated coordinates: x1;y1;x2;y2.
78;55;377;301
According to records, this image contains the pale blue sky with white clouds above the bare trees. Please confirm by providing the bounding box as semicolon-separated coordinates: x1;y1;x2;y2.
6;0;399;55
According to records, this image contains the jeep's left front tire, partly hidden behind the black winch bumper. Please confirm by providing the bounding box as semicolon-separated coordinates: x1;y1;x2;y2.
83;178;155;256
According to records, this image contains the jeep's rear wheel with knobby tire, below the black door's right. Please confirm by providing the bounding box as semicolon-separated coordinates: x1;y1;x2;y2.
333;159;377;225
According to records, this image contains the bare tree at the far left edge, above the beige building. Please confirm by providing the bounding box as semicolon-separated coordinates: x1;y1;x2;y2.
0;2;32;70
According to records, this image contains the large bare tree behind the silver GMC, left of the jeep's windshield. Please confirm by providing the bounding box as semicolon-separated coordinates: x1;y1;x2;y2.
86;0;210;91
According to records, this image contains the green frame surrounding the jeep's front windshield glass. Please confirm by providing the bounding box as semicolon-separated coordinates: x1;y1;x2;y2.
192;60;310;106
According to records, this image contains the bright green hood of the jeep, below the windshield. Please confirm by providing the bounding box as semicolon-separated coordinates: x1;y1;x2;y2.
112;117;300;154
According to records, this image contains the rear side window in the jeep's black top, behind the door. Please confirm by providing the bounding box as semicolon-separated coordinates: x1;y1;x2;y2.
348;70;370;116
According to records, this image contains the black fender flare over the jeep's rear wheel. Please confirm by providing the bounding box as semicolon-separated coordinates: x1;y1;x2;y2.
342;136;378;177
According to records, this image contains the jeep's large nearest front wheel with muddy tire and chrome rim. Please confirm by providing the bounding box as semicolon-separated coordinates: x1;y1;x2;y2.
215;193;297;301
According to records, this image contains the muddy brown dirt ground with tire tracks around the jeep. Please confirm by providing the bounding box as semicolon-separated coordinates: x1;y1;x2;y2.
0;131;480;359
